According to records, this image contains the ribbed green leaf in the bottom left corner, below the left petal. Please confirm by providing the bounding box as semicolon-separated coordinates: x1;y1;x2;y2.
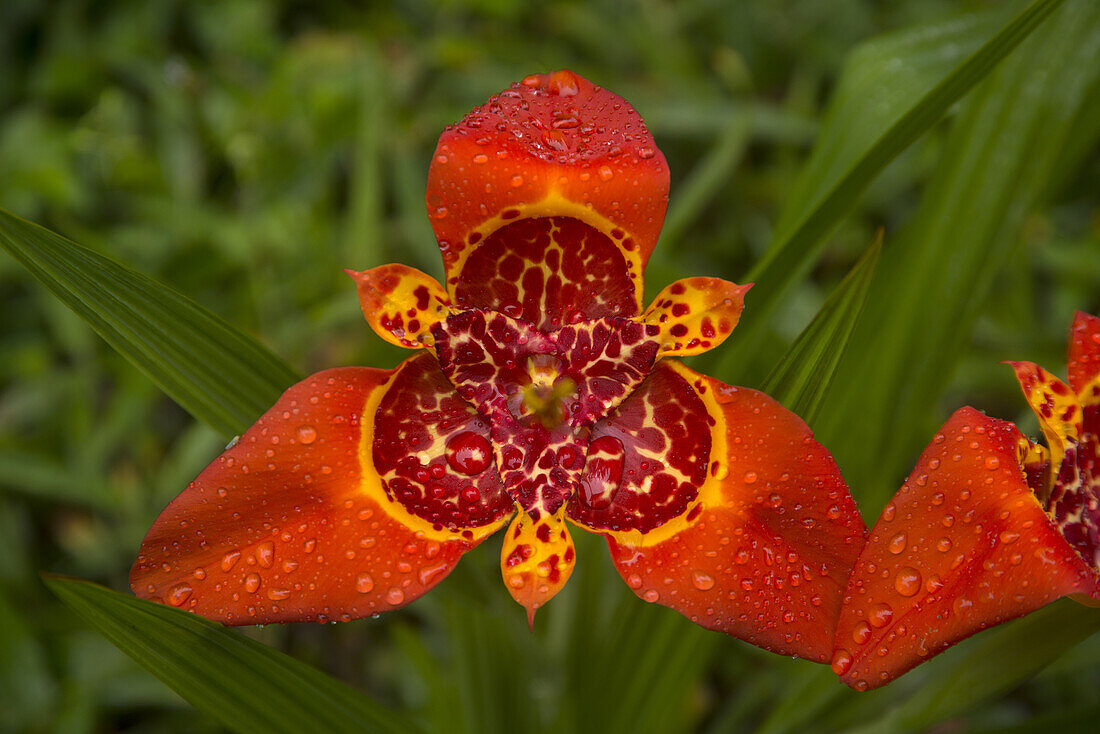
45;577;419;734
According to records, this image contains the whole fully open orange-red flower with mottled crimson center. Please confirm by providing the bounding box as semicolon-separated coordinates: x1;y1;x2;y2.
131;72;866;661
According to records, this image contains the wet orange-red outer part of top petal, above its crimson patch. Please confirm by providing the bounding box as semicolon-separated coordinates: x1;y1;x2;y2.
427;72;669;293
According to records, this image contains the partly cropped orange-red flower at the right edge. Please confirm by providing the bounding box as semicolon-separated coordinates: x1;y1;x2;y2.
833;311;1100;690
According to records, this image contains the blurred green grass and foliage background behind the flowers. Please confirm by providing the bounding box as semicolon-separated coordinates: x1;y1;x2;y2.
0;0;1100;733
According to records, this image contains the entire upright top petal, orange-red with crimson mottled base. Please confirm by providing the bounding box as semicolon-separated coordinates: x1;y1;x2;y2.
427;72;669;326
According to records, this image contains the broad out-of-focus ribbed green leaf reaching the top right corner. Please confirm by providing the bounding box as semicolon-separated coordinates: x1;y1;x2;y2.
818;0;1100;511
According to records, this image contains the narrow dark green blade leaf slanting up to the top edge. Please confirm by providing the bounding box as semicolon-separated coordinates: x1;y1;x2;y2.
718;0;1064;381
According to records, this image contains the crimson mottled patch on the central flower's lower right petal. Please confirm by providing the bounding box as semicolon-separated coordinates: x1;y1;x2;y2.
567;363;711;533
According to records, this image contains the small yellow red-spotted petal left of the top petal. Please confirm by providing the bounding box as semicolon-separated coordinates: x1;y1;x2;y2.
344;264;451;349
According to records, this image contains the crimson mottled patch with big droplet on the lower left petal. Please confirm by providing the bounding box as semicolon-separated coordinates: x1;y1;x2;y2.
372;354;512;529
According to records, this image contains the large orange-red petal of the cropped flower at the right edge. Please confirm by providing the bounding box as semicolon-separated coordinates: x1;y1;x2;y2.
833;407;1098;690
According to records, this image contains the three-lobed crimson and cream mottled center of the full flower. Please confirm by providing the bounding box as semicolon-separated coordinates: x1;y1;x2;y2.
432;309;659;519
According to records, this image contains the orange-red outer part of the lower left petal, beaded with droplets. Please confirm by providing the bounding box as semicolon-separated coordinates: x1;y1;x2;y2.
130;355;504;624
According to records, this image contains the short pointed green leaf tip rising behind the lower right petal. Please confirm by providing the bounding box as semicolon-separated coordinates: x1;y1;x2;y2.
762;230;882;425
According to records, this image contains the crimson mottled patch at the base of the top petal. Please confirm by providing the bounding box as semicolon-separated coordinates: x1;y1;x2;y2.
455;212;638;329
